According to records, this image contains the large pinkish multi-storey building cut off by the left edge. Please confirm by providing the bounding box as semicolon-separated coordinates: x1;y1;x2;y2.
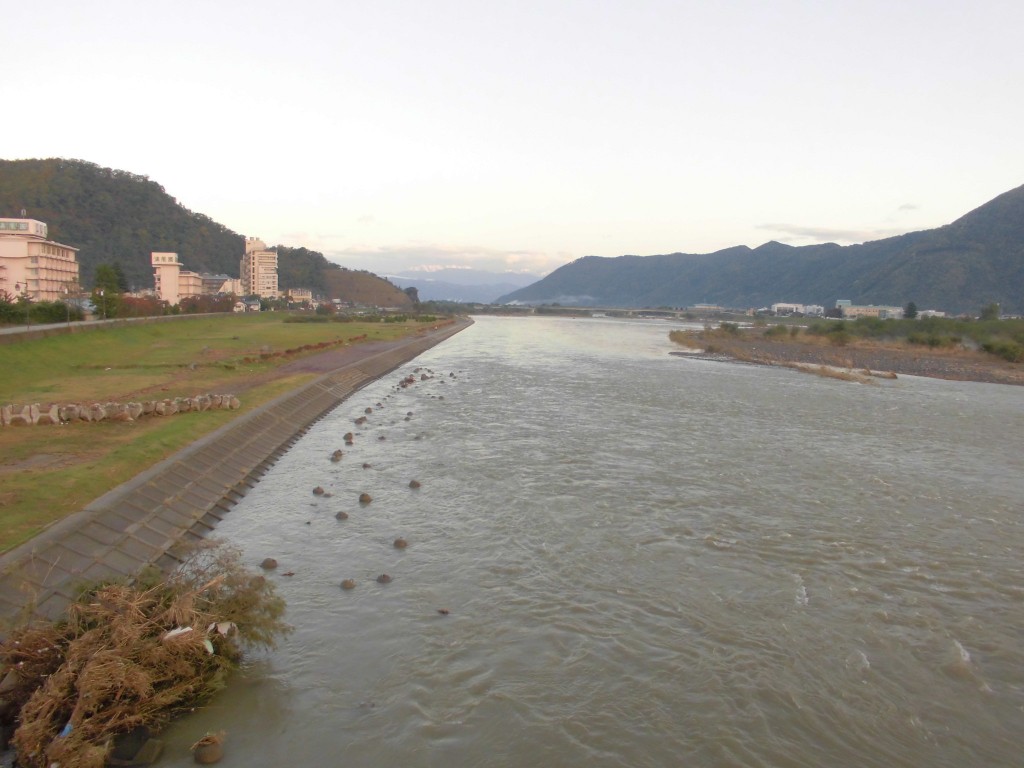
0;218;79;301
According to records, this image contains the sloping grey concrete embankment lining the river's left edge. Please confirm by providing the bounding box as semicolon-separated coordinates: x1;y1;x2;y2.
0;318;472;626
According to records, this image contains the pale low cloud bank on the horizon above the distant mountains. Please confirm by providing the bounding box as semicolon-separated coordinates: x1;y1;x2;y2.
324;245;573;275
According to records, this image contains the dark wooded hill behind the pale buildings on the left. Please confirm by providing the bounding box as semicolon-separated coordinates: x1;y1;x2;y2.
0;159;412;307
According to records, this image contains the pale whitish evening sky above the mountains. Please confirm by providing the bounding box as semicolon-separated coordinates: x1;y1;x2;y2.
0;0;1024;274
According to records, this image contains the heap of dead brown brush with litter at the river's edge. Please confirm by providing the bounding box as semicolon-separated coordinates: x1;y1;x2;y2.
0;542;289;768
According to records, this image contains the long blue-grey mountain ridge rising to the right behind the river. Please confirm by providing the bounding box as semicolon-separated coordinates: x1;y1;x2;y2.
496;186;1024;313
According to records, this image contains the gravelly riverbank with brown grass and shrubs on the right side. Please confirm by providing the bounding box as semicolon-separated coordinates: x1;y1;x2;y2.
676;333;1024;386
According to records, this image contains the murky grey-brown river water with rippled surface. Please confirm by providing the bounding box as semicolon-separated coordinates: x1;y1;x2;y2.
163;317;1024;768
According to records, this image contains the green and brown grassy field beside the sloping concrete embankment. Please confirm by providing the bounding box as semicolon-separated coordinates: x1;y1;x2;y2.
0;312;422;552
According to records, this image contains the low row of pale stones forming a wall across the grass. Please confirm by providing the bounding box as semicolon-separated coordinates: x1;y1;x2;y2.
0;394;242;427
